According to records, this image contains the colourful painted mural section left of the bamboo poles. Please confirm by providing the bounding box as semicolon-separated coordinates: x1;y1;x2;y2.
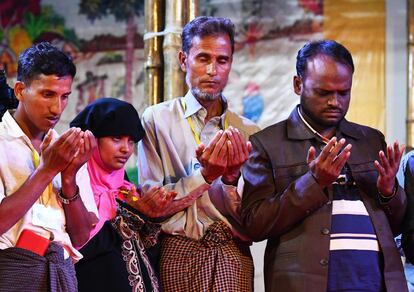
0;0;145;130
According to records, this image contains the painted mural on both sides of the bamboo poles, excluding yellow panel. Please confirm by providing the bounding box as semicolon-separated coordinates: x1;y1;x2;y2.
0;0;323;130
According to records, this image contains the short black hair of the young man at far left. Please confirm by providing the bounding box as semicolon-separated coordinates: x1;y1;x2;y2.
17;42;76;84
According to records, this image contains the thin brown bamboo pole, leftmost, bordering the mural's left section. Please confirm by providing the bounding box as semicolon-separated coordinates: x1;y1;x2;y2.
144;0;164;105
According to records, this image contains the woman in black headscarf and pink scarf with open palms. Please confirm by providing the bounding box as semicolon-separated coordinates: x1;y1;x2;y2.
70;98;196;292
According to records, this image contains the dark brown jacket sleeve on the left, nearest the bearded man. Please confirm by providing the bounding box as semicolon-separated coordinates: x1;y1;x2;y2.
242;136;328;241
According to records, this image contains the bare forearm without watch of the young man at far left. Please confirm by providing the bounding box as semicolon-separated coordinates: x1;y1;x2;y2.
0;168;55;234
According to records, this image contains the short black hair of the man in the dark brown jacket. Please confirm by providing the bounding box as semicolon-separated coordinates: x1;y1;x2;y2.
296;40;355;78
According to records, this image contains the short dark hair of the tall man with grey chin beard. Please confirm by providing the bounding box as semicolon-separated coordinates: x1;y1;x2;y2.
181;16;234;54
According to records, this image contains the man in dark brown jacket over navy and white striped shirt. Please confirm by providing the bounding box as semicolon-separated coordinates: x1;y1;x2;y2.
242;40;407;291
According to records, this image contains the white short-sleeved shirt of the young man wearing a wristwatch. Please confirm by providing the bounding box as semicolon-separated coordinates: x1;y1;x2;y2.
0;112;98;261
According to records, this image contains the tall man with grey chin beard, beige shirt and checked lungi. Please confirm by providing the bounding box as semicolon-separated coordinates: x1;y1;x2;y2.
138;17;258;292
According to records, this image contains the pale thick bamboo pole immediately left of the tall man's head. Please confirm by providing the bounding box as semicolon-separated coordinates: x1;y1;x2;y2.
163;0;185;100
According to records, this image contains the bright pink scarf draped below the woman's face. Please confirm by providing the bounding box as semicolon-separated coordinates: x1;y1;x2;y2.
88;147;131;239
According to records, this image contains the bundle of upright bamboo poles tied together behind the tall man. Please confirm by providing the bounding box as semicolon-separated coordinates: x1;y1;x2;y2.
144;0;199;105
